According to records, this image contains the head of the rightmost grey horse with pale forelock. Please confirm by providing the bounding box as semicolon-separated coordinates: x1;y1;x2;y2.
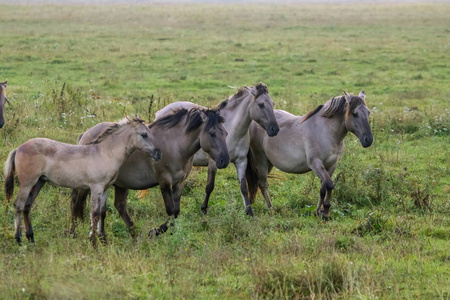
344;91;373;148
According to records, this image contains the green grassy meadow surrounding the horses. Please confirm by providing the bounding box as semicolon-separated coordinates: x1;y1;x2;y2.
0;2;450;299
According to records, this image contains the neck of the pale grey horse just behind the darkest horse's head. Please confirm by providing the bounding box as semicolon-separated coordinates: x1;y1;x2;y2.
220;94;253;139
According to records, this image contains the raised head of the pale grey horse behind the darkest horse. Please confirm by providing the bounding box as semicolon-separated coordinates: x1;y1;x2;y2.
246;82;280;136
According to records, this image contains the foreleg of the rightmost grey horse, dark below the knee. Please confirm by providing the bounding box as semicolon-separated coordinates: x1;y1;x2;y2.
309;159;334;220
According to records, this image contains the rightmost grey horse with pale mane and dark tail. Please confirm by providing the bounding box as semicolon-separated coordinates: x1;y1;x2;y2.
246;91;373;220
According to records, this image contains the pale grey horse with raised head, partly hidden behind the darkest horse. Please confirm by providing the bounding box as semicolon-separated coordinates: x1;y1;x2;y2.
156;82;279;216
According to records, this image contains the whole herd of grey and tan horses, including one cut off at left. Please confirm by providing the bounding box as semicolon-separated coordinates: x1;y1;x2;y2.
0;82;373;245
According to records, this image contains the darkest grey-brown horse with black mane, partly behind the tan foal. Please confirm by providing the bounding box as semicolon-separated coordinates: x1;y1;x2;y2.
71;108;230;237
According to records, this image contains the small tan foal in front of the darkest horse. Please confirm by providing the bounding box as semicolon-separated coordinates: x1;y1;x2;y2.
4;118;161;246
